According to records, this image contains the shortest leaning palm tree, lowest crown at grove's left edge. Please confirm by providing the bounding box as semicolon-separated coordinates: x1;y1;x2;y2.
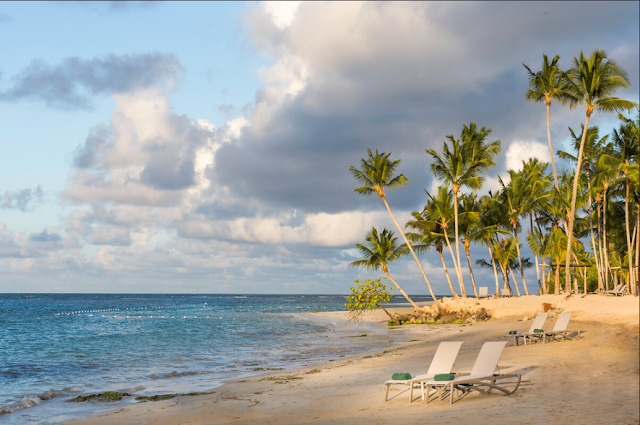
350;227;419;310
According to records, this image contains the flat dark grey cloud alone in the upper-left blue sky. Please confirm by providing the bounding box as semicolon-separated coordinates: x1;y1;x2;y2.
0;53;182;109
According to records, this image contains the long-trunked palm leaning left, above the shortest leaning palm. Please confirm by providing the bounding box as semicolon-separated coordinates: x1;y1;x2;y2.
349;149;440;308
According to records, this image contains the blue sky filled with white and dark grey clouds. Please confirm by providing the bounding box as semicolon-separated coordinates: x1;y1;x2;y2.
0;2;640;294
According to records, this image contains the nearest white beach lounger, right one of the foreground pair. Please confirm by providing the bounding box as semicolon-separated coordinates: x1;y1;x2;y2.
422;341;522;404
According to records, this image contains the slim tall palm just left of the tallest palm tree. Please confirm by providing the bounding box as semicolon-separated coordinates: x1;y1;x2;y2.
522;54;570;190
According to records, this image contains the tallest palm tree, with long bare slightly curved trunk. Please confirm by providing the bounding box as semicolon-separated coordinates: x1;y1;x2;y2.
565;50;638;288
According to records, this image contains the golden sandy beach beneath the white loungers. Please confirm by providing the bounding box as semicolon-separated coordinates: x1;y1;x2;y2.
67;295;640;425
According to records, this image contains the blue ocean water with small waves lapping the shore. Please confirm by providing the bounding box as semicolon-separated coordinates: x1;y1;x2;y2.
0;294;431;425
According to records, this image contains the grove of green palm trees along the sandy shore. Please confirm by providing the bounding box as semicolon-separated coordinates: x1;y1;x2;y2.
350;50;640;298
